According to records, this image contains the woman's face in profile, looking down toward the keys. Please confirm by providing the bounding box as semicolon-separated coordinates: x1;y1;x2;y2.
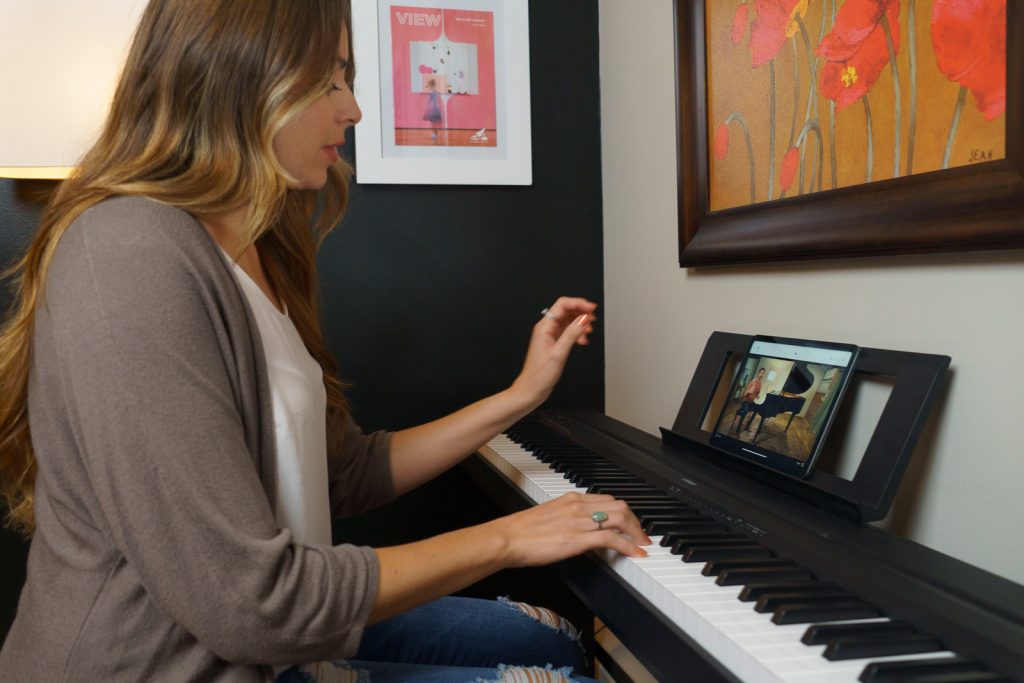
273;32;362;189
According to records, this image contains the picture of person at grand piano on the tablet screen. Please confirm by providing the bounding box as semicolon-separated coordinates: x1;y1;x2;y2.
718;357;845;461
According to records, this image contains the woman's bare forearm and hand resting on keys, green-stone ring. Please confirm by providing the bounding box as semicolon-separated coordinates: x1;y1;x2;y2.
370;494;650;623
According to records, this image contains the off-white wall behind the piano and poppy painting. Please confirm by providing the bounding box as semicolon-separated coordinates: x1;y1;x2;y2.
599;0;1024;583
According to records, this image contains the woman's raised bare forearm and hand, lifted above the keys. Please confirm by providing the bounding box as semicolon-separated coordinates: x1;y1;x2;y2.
390;297;597;495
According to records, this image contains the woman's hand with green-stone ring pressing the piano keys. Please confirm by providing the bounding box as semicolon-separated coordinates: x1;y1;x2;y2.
487;493;650;566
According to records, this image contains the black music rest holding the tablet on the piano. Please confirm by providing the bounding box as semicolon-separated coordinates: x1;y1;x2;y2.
662;332;949;523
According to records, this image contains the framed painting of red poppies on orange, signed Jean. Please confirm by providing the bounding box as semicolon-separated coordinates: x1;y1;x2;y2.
676;0;1024;267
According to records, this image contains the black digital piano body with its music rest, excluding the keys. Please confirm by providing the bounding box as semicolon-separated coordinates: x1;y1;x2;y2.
464;333;1024;681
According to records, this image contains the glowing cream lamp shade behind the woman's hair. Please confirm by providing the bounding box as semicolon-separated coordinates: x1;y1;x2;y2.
0;0;145;178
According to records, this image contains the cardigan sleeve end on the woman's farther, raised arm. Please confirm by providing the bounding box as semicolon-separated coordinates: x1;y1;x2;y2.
328;415;394;517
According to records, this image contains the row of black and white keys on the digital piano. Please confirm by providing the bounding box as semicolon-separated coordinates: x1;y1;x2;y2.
480;423;1010;683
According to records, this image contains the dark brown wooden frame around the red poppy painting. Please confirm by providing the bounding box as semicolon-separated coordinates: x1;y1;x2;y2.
675;0;1024;267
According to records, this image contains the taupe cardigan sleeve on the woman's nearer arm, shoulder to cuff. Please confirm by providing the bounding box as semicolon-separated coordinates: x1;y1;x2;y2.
32;203;379;665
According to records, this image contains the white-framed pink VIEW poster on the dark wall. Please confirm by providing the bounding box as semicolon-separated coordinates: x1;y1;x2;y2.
352;0;532;185
